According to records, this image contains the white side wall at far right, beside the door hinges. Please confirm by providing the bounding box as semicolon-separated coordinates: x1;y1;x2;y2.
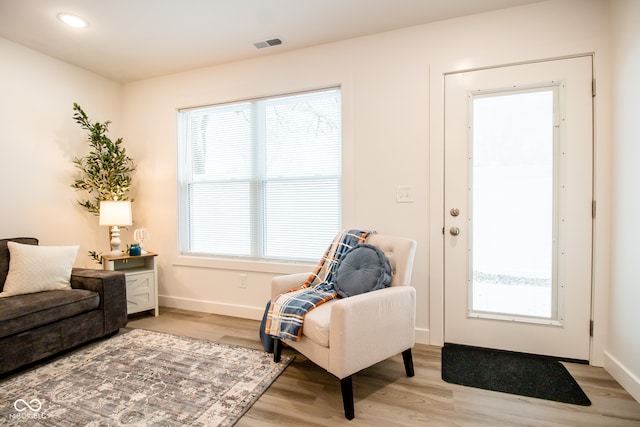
605;0;640;401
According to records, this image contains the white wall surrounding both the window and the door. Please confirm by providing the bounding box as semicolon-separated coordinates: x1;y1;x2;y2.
123;0;609;360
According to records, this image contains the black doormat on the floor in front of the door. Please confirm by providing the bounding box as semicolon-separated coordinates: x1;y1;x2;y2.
442;343;591;406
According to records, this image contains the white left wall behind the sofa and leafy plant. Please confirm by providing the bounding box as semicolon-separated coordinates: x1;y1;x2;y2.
0;38;121;267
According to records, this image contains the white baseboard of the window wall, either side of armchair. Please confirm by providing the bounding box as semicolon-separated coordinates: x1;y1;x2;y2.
158;295;430;344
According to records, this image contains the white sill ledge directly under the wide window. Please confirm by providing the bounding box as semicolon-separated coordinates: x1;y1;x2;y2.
172;255;315;274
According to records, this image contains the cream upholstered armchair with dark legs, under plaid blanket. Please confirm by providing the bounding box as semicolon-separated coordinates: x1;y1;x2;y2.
271;234;416;419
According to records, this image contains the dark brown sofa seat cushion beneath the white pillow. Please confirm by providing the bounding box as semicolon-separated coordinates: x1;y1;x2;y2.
0;289;100;338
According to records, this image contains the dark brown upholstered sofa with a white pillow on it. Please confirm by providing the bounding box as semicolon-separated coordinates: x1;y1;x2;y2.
0;237;127;375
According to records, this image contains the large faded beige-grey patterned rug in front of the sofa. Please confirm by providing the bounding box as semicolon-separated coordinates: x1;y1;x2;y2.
0;329;293;427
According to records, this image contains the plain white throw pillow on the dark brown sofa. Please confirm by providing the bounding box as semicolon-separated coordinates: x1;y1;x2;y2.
0;242;79;297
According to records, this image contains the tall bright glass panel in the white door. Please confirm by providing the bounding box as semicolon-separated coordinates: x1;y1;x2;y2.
469;87;557;319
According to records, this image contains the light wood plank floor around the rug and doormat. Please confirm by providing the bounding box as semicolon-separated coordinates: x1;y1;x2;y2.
127;308;640;427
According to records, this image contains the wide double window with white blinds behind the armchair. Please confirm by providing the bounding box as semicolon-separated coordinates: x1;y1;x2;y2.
178;89;342;261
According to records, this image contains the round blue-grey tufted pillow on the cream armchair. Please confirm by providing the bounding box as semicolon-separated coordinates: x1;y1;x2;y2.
334;243;391;298
